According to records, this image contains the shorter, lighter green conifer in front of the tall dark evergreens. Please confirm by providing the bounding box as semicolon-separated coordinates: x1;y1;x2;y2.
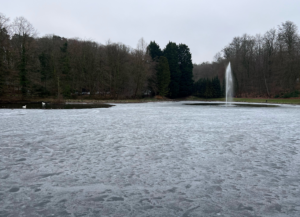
157;56;170;96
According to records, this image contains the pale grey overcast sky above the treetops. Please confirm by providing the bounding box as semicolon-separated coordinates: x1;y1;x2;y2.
0;0;300;63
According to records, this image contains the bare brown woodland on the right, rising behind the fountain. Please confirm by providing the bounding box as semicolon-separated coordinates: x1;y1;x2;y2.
193;21;300;97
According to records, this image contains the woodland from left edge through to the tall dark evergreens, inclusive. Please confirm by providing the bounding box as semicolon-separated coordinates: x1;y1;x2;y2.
0;14;193;98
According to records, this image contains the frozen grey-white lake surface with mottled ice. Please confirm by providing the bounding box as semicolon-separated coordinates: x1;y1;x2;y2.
0;102;300;217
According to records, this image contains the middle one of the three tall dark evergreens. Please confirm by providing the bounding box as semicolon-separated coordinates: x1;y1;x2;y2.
163;42;181;98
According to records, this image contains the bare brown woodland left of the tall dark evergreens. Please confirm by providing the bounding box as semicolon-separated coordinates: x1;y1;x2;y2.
0;14;154;98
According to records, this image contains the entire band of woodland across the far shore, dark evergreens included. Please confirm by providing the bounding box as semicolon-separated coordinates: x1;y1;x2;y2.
0;11;300;99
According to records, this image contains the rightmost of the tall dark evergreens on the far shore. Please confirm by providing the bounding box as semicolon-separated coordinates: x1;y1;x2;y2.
178;44;194;97
